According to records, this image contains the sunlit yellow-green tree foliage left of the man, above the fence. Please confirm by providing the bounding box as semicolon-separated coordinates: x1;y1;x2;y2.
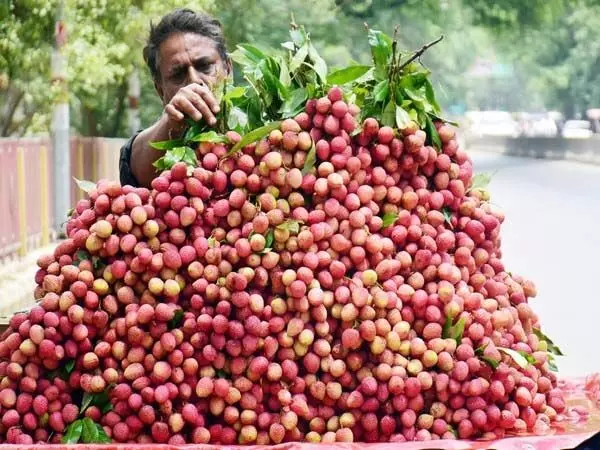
0;0;212;136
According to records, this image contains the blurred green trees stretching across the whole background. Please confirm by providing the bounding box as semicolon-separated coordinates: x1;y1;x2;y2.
0;0;600;136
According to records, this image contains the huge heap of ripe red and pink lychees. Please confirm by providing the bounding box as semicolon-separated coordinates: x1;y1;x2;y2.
0;81;564;446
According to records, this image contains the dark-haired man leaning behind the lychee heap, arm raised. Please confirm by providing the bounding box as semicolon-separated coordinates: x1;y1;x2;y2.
119;9;231;187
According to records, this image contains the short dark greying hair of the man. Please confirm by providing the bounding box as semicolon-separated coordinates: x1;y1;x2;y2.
144;9;229;80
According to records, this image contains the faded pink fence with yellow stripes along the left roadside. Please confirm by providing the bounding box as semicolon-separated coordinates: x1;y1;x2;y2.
0;137;124;260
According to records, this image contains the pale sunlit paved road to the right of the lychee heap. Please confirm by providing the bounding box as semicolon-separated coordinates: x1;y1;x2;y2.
471;153;600;376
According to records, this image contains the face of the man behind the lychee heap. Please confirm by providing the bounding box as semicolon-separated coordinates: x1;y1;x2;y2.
155;33;230;104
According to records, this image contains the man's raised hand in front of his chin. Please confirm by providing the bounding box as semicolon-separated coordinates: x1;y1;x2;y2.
165;83;220;128
